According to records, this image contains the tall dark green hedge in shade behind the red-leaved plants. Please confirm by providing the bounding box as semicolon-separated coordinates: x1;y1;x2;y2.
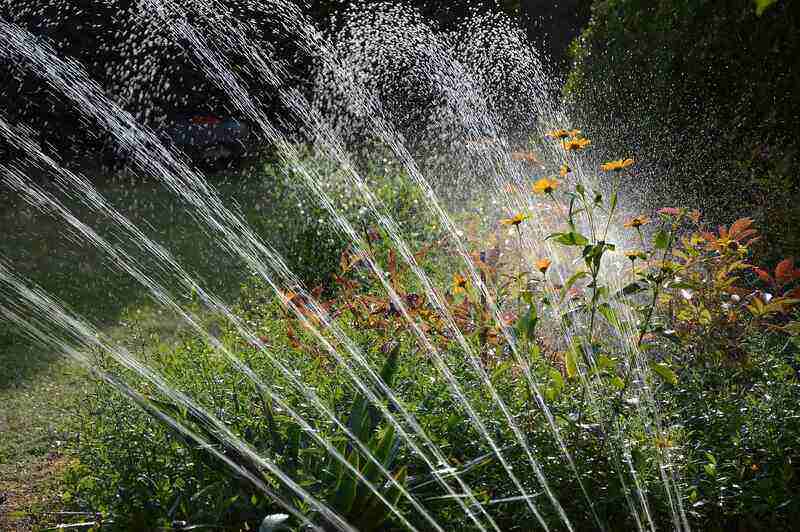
566;0;800;253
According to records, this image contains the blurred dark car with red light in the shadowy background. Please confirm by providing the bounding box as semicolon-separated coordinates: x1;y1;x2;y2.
104;112;252;169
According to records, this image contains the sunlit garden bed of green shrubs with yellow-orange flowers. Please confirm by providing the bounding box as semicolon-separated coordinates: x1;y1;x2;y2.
62;136;800;530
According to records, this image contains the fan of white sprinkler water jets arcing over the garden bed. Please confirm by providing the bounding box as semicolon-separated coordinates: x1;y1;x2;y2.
0;0;689;530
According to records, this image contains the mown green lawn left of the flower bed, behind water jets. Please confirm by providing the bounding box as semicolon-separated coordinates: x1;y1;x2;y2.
0;164;322;530
